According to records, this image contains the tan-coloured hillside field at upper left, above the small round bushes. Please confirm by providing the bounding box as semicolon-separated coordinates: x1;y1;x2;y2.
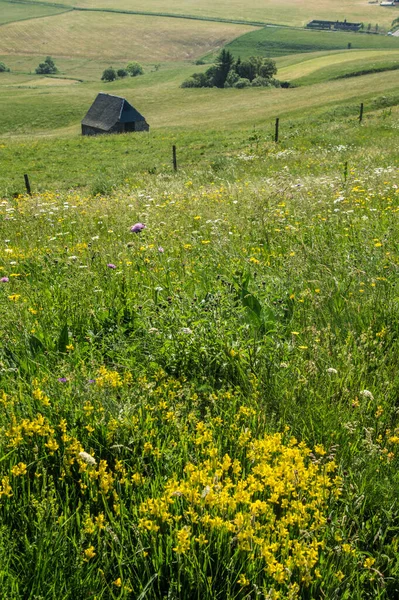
0;9;252;64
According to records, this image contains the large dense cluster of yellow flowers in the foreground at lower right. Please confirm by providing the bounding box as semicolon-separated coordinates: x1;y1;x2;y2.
139;434;342;585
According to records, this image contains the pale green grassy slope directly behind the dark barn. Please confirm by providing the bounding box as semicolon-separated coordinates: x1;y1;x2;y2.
0;57;399;135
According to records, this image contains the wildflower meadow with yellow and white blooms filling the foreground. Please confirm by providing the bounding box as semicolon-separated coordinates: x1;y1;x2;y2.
0;108;399;600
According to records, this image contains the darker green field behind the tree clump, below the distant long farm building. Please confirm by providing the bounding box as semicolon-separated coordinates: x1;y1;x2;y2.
223;27;399;59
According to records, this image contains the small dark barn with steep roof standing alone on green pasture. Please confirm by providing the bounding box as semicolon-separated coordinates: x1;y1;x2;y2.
82;92;150;135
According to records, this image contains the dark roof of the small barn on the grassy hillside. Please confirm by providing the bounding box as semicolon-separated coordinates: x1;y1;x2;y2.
82;92;145;131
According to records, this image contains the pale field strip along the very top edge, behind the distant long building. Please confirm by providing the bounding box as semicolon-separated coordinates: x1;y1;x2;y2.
26;0;398;28
